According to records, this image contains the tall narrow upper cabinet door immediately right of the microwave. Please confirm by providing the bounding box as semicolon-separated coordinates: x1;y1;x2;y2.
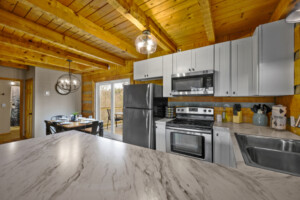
215;42;231;96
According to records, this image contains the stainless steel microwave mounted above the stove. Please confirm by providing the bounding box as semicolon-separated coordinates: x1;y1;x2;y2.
171;70;214;96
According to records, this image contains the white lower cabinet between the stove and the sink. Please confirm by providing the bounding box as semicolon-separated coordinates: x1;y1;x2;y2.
213;127;236;167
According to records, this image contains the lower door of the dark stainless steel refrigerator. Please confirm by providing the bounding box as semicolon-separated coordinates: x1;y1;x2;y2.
123;108;155;149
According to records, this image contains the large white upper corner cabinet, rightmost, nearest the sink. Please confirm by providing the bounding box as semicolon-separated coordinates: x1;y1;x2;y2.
253;20;294;96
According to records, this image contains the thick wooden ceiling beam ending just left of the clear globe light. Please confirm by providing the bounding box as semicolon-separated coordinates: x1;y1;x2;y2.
19;0;143;58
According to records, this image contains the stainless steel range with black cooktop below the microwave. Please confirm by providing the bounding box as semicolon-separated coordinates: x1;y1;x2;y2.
166;107;214;162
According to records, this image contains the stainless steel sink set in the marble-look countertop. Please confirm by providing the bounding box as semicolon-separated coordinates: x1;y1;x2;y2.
235;133;300;176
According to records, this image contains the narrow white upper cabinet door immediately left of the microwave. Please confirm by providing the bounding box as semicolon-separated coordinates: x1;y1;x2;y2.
163;54;173;97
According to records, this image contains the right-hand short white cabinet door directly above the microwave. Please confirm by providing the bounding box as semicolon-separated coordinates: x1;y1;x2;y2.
192;45;214;71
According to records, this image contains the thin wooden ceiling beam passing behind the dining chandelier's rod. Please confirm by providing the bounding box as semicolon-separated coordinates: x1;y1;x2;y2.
0;55;82;73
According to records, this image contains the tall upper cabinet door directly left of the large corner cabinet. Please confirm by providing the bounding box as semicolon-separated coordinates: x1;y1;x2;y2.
231;37;253;96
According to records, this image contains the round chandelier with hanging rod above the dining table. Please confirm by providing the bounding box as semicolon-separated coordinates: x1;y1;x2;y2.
56;59;81;95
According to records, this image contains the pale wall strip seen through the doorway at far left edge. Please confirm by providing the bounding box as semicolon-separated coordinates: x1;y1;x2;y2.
0;80;11;134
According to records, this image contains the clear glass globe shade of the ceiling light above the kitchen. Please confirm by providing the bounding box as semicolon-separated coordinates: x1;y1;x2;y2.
135;30;157;54
